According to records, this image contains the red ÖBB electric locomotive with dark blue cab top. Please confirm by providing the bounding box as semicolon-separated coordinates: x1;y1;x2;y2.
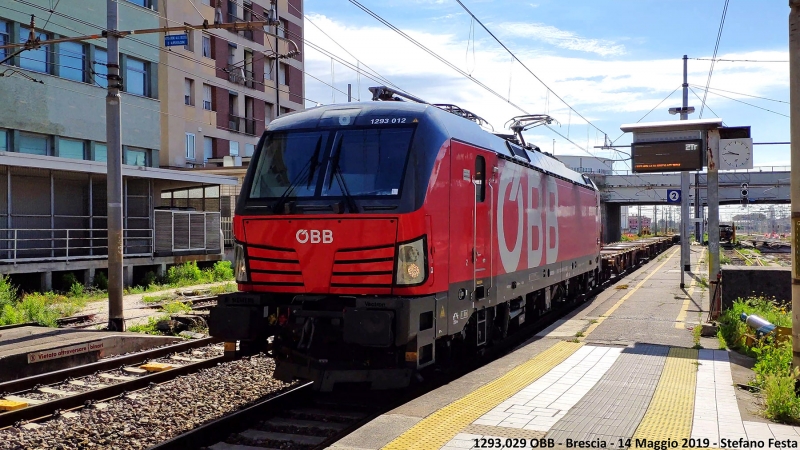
209;92;601;390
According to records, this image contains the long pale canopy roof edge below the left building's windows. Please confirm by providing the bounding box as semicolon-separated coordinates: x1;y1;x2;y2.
0;152;237;186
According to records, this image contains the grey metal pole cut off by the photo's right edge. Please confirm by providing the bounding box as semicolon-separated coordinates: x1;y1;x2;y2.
789;0;800;367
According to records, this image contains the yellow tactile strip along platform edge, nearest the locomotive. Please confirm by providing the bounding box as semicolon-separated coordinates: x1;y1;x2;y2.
383;342;583;450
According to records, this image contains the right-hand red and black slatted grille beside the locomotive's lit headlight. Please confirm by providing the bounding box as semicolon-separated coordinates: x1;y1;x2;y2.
331;245;394;292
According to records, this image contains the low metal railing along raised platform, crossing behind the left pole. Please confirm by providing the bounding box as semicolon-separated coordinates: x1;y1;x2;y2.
0;228;153;264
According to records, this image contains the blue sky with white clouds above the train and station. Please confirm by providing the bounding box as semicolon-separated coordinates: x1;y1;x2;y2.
304;0;790;169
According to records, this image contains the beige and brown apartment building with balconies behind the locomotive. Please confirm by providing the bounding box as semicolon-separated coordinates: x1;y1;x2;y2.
158;0;304;168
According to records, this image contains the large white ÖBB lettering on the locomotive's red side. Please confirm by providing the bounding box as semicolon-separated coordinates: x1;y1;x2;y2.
497;164;559;273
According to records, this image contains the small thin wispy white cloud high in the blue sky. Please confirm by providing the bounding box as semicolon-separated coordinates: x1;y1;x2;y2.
500;22;625;56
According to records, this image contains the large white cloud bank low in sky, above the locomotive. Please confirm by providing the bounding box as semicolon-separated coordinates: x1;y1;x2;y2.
304;15;789;158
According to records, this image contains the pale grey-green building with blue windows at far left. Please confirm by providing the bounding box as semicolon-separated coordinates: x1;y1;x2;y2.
0;0;236;289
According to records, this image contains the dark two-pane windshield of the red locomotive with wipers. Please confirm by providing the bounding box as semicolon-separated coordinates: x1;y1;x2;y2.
249;127;414;199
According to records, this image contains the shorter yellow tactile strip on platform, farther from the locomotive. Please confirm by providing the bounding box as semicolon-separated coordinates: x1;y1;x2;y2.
631;348;698;448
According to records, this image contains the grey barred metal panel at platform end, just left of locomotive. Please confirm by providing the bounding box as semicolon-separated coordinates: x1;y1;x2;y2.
154;210;222;254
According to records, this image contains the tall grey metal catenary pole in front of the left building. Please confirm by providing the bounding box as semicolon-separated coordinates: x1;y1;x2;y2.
106;0;125;331
